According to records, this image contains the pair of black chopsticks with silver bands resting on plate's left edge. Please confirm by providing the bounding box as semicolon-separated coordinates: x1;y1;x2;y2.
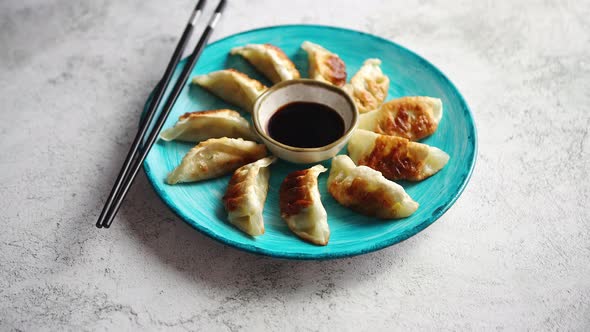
96;0;226;228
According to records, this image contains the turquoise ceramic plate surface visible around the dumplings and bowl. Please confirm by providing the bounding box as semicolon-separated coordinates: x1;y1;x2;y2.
144;25;476;259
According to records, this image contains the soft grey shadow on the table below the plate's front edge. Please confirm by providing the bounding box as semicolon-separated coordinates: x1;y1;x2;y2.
117;172;421;295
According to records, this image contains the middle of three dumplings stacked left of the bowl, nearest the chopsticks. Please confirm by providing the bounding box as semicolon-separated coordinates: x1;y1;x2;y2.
160;109;259;142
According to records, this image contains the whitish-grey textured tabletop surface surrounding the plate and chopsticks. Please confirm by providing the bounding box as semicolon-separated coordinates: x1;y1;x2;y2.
0;0;590;331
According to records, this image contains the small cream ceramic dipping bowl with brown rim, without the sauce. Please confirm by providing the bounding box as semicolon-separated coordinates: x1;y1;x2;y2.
252;79;358;164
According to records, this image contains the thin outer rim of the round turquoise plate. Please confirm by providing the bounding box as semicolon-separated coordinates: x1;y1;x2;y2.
140;24;478;260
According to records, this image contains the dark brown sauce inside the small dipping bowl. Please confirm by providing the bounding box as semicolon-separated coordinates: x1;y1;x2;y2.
268;101;344;148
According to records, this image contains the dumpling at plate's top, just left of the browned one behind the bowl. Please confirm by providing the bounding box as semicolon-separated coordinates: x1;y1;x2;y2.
231;44;301;83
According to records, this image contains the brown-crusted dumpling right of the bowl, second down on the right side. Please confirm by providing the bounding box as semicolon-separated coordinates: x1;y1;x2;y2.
358;97;443;141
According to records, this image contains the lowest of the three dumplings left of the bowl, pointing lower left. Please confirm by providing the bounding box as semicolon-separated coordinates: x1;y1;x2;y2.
166;137;266;184
